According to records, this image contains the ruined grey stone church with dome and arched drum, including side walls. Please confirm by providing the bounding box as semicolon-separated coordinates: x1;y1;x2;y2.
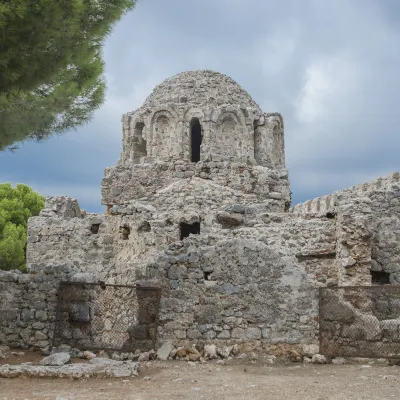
3;70;400;354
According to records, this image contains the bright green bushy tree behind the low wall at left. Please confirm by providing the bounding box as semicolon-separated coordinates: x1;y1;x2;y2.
0;183;44;270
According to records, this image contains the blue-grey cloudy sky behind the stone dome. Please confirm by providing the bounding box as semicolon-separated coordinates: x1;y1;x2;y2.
0;0;400;212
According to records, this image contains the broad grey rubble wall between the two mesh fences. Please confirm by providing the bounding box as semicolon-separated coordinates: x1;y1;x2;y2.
137;214;339;347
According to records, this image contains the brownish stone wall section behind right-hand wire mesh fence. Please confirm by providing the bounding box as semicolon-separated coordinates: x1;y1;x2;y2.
320;285;400;358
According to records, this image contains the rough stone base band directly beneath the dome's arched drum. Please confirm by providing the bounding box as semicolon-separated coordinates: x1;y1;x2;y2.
102;156;290;212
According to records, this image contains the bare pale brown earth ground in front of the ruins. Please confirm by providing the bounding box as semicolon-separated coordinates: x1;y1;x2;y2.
0;362;400;400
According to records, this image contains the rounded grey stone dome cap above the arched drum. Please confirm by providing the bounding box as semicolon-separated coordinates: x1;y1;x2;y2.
143;70;260;110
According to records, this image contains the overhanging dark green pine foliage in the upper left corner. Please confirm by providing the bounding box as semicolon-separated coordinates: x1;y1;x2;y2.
0;0;135;150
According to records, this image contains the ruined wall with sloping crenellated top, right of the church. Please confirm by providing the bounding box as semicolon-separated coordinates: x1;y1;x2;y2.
290;172;400;285
